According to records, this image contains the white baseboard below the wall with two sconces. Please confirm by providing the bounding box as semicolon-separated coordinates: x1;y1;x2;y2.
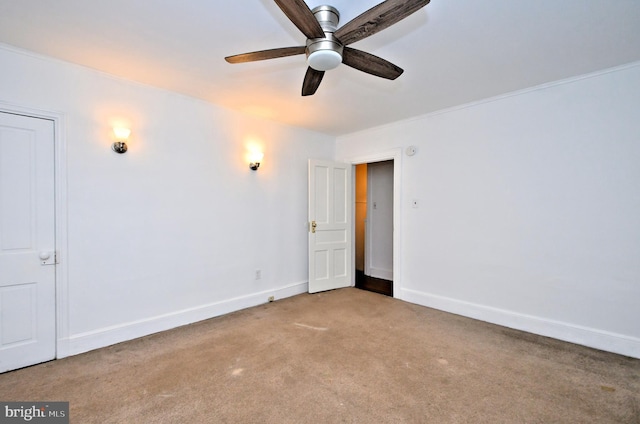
57;281;309;359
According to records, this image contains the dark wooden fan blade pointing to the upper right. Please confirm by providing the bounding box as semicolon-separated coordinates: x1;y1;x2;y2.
334;0;431;46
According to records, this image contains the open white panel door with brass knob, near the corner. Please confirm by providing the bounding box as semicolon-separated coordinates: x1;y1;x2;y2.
309;160;353;293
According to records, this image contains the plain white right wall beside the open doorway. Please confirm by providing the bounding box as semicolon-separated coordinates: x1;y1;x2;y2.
336;63;640;357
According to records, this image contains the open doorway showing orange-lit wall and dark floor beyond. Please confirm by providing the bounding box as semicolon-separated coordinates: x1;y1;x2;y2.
355;160;394;296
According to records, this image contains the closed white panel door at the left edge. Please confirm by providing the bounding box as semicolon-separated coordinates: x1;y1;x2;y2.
0;112;56;372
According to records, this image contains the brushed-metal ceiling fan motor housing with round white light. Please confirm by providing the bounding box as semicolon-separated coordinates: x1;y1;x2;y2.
306;6;344;71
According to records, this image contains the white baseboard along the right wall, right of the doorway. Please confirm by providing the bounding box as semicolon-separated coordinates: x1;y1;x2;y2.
399;289;640;359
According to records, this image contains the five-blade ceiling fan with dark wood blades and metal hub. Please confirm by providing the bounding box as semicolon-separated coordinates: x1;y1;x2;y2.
225;0;431;96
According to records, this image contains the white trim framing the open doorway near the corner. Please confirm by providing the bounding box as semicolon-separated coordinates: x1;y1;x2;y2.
341;148;403;299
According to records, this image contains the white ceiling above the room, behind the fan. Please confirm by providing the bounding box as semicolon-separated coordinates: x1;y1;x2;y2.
0;0;640;135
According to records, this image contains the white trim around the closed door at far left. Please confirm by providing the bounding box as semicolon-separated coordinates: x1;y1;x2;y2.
0;101;69;359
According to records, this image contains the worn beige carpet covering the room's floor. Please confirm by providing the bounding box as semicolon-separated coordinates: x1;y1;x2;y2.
0;288;640;424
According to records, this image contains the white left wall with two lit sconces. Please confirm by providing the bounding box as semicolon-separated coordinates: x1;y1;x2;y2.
0;47;334;357
